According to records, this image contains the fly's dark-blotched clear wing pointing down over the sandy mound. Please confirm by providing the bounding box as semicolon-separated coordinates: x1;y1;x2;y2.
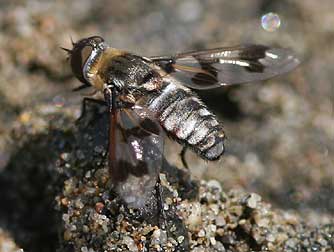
109;105;163;208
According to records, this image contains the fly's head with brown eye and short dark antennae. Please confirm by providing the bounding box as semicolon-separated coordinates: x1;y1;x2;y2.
63;36;108;90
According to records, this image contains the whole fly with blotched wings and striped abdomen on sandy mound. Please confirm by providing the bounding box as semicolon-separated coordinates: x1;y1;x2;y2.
63;36;299;208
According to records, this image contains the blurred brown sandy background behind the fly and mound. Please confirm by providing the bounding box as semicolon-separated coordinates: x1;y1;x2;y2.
0;0;334;245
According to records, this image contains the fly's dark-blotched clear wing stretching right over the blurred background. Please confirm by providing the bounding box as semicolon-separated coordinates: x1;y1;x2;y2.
151;45;299;89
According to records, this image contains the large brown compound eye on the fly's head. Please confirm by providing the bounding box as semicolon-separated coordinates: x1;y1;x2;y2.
71;44;93;83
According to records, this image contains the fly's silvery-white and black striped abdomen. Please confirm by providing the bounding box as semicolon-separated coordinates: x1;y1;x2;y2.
148;81;224;160
